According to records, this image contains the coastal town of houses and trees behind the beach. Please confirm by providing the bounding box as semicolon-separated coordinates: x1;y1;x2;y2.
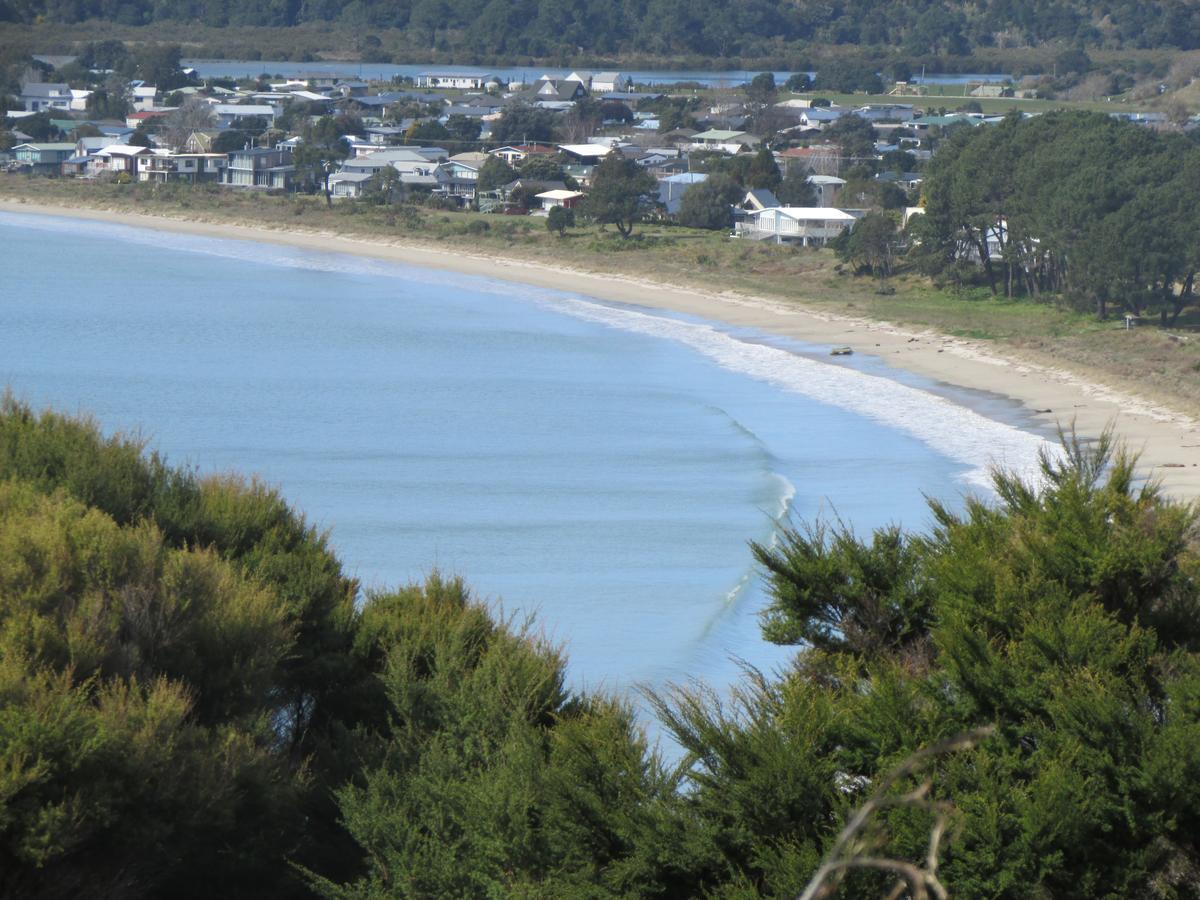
0;58;1060;246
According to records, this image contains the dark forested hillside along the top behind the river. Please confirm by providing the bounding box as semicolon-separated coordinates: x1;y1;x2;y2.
7;0;1200;56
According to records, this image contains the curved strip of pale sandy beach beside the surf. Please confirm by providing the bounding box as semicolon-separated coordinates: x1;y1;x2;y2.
9;200;1200;499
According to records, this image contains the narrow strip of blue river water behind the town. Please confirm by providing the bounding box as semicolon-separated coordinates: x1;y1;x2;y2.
181;59;1012;88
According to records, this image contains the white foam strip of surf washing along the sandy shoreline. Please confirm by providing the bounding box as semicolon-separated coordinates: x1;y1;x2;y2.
0;212;1056;487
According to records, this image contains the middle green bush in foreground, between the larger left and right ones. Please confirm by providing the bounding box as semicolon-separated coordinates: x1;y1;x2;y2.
302;576;670;898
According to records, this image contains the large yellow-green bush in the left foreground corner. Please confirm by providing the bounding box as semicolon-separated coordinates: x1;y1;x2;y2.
0;400;364;896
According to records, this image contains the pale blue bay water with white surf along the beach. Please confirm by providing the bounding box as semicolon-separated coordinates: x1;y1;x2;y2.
0;214;1044;690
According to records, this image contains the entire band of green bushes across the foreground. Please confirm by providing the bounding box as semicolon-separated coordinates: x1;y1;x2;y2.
0;391;1200;898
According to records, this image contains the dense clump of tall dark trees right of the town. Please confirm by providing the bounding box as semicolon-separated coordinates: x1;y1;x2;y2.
914;113;1200;320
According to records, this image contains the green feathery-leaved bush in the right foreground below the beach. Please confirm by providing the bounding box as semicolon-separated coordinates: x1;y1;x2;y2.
658;436;1200;898
